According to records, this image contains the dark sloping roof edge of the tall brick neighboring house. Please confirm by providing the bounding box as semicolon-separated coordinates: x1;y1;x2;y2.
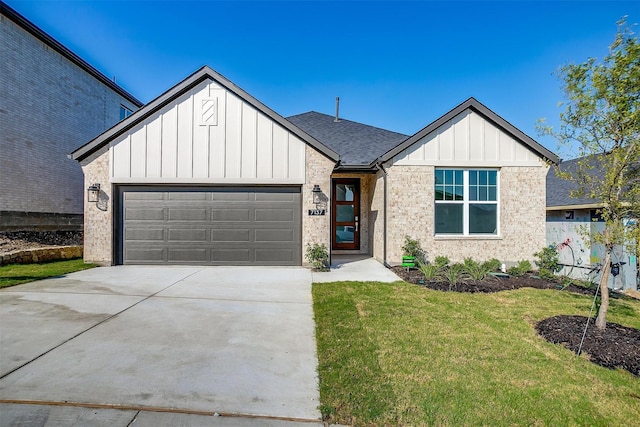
0;1;143;107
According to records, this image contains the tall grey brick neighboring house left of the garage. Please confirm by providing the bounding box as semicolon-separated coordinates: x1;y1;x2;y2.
0;1;142;231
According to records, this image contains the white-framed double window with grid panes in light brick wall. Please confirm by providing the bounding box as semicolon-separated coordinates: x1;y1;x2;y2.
434;169;499;236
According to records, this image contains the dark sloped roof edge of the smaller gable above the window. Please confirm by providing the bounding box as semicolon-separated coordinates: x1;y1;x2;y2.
377;97;560;164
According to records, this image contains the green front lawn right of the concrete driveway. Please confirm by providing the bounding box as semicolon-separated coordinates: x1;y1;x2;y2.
313;282;640;426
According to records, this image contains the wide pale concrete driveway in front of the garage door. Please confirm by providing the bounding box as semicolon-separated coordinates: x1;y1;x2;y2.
0;266;320;422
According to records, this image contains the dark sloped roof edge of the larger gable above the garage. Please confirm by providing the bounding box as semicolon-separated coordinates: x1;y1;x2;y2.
71;65;339;162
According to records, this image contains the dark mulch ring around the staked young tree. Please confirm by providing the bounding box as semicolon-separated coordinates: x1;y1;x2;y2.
536;316;640;376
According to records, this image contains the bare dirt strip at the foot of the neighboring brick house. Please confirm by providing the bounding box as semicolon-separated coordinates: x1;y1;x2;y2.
0;231;83;254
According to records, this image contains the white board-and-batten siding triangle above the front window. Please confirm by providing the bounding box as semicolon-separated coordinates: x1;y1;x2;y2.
393;110;544;167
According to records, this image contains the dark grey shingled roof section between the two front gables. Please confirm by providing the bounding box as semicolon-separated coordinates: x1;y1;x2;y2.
287;111;409;169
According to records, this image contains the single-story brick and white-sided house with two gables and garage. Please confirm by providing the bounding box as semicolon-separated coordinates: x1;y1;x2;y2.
72;66;558;265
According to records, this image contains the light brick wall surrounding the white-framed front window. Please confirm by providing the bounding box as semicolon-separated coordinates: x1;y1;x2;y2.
382;165;547;265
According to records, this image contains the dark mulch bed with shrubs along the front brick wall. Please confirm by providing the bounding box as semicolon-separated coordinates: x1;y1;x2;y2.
391;266;595;295
